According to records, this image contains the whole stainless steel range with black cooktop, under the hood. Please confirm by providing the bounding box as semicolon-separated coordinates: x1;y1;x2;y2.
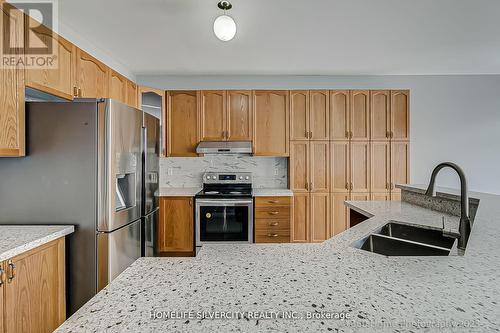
195;172;253;246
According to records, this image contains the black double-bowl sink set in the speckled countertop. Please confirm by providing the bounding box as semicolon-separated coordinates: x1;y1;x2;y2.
354;221;457;256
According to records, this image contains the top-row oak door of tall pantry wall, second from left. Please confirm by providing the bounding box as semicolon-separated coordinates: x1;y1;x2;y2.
309;90;330;140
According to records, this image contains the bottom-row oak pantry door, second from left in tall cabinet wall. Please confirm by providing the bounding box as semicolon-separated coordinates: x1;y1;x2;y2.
310;193;330;242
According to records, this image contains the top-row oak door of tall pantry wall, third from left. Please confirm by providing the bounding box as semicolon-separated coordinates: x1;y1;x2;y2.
329;90;350;140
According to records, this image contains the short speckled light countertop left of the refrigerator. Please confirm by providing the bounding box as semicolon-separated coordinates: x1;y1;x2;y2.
0;225;75;261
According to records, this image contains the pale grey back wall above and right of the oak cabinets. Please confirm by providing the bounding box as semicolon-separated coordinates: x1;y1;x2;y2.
138;75;500;194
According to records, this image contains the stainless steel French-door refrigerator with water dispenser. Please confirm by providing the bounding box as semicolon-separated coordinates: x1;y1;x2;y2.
0;99;147;314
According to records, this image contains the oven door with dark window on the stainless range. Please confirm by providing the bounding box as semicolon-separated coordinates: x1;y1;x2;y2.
196;199;253;246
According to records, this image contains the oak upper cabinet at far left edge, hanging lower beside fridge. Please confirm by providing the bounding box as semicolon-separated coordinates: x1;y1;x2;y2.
0;3;25;156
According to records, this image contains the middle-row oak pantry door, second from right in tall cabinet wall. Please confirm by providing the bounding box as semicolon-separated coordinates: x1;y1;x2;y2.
370;142;391;192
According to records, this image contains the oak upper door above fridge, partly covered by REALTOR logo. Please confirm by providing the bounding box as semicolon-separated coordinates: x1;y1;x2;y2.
24;16;76;100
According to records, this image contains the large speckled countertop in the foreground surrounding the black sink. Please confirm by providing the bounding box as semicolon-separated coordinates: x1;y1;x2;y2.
57;185;500;332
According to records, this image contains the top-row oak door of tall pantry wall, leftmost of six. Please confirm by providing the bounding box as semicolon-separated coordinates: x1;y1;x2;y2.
290;90;309;140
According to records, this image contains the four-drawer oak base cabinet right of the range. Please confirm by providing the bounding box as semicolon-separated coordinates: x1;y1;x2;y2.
255;197;292;243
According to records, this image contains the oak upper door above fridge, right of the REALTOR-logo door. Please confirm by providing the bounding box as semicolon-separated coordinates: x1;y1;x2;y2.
76;49;110;98
